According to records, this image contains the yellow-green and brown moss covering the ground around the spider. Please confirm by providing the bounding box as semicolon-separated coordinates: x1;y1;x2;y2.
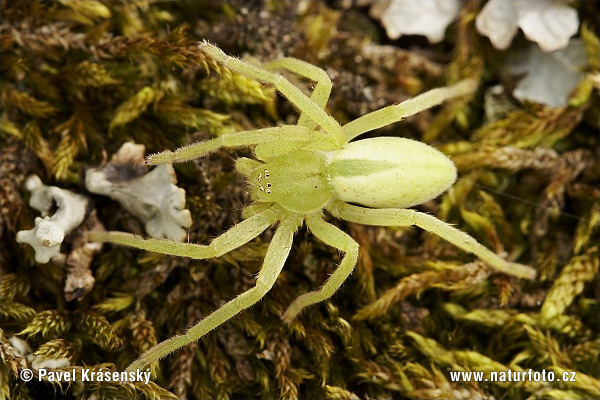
0;1;600;399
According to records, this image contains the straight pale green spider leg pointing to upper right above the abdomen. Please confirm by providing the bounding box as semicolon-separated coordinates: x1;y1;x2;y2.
342;80;477;142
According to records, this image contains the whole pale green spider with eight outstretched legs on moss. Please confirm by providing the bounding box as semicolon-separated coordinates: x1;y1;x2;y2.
90;41;535;371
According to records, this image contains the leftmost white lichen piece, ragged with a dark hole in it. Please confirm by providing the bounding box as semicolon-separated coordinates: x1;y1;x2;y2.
17;175;89;263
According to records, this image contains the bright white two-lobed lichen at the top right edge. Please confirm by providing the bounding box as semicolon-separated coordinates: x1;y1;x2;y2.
475;0;579;52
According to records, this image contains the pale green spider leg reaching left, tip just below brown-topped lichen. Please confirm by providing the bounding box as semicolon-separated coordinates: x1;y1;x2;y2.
87;210;278;260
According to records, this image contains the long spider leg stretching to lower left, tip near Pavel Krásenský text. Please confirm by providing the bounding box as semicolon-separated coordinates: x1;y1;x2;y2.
127;217;302;372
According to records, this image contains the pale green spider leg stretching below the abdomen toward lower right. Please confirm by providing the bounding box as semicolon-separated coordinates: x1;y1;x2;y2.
329;201;536;279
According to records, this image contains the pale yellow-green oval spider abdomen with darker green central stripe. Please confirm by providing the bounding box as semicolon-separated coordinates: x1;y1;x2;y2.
327;137;456;208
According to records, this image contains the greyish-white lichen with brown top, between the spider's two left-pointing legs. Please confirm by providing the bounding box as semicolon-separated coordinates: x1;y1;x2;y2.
85;142;192;242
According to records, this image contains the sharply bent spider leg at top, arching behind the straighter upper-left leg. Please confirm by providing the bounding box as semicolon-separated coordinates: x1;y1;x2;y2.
264;57;332;129
